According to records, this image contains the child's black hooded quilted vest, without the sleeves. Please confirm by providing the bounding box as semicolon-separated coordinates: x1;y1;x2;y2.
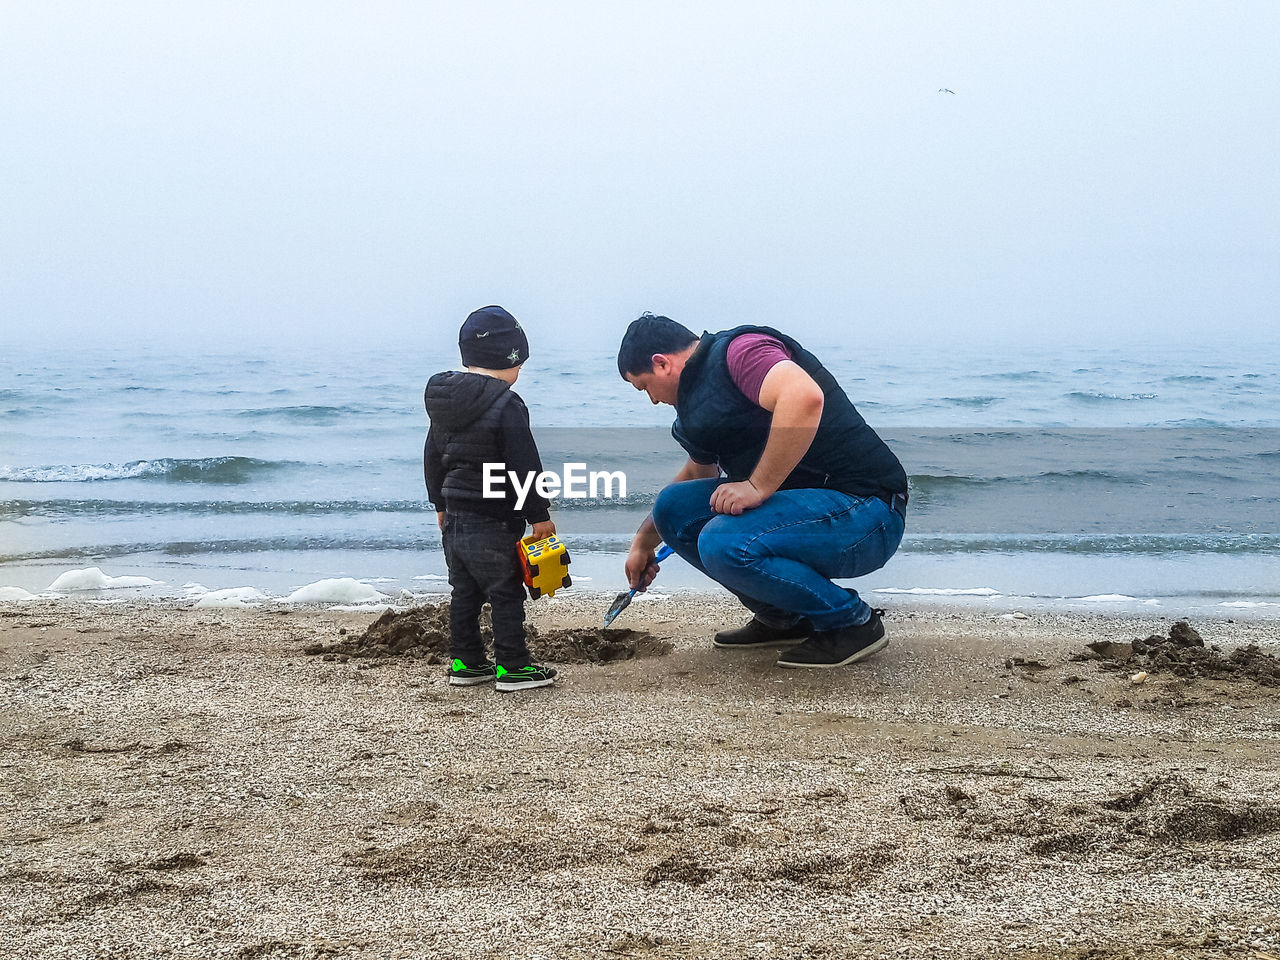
424;372;515;512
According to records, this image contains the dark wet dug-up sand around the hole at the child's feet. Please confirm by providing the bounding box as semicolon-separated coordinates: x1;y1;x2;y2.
305;602;672;663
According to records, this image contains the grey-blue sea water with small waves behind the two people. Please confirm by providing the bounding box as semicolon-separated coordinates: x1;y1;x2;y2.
0;332;1280;616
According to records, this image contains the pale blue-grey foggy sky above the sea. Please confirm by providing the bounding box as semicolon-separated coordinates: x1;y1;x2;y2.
0;0;1280;353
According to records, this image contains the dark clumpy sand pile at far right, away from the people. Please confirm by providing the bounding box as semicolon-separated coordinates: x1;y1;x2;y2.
1073;620;1280;686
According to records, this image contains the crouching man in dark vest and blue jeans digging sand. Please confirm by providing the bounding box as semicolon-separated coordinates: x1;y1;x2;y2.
618;314;906;668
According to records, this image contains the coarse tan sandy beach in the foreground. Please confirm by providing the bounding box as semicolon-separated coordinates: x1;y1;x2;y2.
0;593;1280;960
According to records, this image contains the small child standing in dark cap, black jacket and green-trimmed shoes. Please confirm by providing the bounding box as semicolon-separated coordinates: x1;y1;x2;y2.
422;306;556;691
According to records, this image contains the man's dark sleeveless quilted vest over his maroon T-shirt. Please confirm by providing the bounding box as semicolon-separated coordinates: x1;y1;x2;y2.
672;326;906;498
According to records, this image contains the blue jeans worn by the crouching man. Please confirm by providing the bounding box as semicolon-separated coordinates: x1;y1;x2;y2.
653;477;905;630
